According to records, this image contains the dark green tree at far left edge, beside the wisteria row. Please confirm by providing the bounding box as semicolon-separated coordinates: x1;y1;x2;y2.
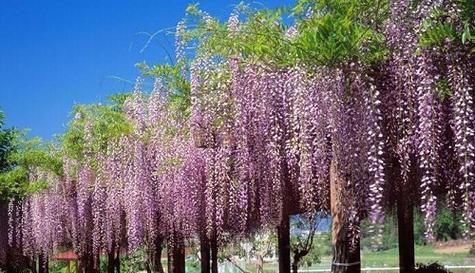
0;111;49;273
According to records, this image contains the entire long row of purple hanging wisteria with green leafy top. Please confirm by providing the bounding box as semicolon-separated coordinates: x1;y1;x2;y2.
3;0;475;273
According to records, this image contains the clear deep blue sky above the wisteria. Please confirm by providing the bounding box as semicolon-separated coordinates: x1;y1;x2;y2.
0;0;294;139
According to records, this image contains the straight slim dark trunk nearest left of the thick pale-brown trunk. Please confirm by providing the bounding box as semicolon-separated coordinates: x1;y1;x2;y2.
277;212;290;273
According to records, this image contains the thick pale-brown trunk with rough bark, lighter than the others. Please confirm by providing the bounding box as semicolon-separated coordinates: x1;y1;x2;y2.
330;160;361;273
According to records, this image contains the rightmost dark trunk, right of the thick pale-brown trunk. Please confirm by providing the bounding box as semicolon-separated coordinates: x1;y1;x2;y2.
397;189;415;273
